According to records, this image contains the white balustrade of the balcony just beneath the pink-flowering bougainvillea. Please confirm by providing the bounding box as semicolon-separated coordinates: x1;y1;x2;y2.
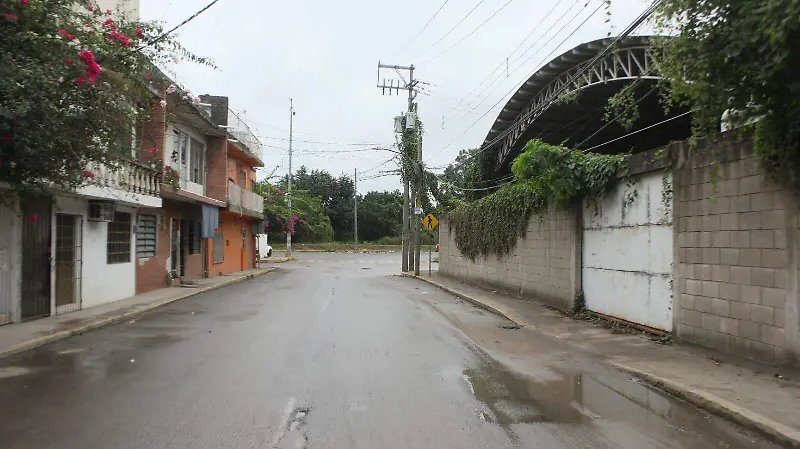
84;160;161;197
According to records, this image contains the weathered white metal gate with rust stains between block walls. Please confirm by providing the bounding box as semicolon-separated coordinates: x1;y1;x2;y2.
582;171;673;332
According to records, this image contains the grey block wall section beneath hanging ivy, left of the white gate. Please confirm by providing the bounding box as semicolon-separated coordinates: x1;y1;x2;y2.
439;208;581;309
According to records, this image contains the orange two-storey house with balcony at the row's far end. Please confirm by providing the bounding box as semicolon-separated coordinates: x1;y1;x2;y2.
200;95;264;276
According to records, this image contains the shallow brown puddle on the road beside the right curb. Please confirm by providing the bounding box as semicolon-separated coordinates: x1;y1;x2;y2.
462;352;778;449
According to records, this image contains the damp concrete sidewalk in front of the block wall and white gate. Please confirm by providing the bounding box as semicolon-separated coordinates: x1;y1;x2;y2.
409;272;800;448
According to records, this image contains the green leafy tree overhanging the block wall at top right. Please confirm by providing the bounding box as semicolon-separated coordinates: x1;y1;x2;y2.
656;0;800;189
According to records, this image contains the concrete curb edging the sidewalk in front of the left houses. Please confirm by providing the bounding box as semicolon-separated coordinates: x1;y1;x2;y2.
0;268;275;359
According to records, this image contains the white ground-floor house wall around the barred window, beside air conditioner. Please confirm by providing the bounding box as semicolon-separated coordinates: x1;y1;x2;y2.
53;196;136;309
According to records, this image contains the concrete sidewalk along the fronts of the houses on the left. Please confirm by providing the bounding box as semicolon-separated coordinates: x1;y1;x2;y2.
0;267;275;358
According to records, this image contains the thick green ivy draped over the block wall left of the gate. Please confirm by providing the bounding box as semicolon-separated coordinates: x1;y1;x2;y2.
448;139;629;260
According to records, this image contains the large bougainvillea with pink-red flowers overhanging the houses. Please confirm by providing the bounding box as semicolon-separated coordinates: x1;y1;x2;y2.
0;0;213;193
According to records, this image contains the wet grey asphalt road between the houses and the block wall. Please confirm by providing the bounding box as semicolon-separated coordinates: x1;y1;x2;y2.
0;253;777;449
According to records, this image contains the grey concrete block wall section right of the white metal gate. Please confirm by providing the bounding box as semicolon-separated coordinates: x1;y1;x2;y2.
672;136;800;363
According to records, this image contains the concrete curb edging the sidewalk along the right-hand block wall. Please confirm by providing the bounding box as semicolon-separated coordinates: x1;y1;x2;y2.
400;273;800;449
